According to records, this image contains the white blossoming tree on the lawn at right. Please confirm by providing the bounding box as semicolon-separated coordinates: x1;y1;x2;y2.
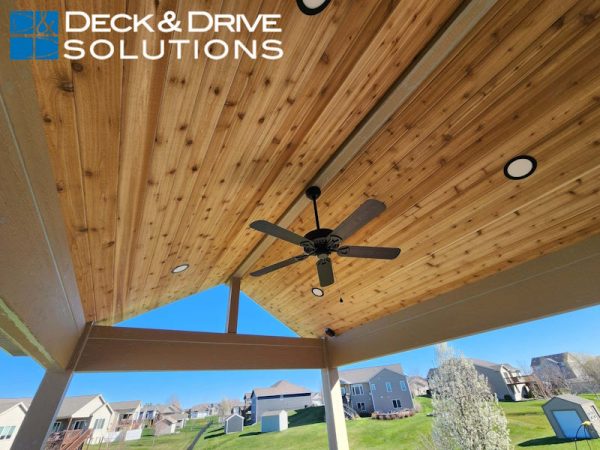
430;344;511;450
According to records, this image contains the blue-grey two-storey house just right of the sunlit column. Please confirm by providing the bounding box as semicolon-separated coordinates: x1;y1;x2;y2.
340;364;414;413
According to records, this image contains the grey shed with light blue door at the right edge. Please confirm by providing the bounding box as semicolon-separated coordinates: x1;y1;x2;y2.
542;394;600;439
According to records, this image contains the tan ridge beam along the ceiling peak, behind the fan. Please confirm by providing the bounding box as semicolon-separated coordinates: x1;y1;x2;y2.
233;0;496;277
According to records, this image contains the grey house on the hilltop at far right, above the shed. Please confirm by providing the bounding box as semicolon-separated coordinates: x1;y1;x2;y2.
531;352;590;393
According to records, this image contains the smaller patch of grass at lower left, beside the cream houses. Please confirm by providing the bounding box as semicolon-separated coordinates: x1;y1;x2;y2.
84;419;207;450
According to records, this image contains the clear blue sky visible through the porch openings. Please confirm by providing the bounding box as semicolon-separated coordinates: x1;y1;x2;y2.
0;286;600;406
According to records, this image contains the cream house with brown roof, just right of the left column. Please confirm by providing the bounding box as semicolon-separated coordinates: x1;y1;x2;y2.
47;394;114;444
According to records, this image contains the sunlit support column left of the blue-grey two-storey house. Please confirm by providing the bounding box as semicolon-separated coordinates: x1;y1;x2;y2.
321;367;350;450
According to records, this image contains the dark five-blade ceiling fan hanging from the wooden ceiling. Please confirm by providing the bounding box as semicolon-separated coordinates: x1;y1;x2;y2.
250;186;400;287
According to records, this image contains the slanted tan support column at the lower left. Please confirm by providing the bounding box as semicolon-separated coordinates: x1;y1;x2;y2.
11;371;73;450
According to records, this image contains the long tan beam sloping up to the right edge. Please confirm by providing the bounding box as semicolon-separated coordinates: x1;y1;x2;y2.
326;235;600;366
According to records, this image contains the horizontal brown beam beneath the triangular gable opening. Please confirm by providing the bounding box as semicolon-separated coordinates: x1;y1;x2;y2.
75;326;324;372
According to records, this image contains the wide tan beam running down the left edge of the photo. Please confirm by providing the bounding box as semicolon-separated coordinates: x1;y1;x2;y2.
0;2;85;370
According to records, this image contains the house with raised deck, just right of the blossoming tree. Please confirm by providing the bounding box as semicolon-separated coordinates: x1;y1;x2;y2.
470;359;536;402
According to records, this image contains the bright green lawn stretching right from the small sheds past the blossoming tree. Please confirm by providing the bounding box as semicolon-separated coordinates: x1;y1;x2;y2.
195;397;600;450
